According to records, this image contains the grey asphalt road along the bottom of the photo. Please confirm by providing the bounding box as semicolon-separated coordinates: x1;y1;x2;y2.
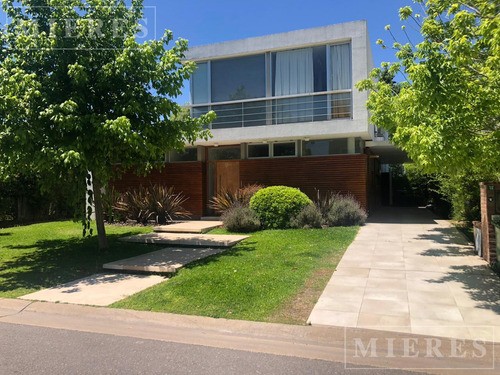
0;323;424;375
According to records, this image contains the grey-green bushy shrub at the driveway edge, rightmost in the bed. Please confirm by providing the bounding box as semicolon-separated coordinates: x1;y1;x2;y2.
327;195;367;227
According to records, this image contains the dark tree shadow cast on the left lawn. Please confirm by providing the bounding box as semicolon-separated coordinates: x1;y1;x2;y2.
0;231;159;293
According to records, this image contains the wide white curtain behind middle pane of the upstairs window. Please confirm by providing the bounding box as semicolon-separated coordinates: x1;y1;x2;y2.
274;48;314;124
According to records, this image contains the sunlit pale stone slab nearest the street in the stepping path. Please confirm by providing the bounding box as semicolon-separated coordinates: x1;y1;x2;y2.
20;273;167;306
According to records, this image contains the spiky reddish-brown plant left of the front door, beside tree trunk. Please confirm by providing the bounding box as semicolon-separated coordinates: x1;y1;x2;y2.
114;185;191;224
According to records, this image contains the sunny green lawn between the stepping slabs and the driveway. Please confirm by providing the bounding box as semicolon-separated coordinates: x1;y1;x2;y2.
111;227;358;323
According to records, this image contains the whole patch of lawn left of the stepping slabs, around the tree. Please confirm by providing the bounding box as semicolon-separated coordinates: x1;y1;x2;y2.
0;221;157;298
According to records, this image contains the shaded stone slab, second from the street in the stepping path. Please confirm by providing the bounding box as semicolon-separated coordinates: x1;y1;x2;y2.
102;247;226;273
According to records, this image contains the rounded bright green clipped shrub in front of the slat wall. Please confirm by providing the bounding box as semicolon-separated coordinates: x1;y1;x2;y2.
250;186;312;229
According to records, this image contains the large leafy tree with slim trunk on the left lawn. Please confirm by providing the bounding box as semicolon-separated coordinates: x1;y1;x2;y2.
0;0;213;248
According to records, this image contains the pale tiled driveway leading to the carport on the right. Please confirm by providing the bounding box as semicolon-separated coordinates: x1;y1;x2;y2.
309;208;500;341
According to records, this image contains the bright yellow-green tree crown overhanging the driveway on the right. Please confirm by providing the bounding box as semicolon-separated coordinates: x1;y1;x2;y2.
357;0;500;183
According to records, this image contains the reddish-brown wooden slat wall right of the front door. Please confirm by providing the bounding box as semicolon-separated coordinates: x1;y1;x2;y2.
240;154;368;208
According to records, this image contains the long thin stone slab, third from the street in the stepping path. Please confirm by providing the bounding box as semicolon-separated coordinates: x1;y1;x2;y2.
120;232;249;247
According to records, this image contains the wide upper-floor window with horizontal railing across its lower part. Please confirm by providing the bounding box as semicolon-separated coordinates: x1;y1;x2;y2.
191;43;352;129
